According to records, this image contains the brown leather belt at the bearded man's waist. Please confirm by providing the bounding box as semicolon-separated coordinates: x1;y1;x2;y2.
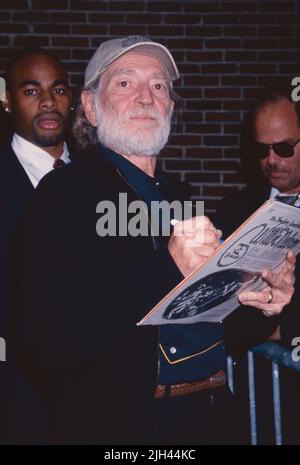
154;370;227;399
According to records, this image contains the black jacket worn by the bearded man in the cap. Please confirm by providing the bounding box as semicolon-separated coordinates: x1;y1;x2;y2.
16;147;224;444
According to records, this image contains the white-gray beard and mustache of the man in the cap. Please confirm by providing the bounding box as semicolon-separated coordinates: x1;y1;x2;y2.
95;99;172;157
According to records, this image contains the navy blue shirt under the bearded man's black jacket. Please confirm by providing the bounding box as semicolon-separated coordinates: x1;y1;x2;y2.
101;147;226;384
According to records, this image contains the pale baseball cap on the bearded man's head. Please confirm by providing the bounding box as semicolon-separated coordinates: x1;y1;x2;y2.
84;36;180;87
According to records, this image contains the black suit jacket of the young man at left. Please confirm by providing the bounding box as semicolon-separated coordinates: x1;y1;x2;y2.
0;144;45;443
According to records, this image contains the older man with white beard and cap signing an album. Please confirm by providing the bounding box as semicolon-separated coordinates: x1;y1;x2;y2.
17;36;294;444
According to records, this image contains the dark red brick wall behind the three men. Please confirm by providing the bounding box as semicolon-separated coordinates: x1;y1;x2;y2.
0;0;300;211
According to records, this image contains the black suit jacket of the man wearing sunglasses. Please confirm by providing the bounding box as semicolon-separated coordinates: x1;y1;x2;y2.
215;183;300;351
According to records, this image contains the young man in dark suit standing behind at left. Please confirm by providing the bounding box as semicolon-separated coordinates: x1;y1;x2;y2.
0;48;71;443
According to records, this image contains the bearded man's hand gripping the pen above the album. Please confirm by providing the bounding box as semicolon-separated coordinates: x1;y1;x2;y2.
168;216;222;277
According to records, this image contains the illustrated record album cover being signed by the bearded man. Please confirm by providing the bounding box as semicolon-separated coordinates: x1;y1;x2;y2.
137;200;300;325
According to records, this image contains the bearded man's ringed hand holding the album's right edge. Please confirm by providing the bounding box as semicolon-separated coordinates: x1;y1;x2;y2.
239;251;296;316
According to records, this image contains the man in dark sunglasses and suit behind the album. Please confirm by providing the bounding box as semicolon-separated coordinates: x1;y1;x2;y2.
216;79;300;444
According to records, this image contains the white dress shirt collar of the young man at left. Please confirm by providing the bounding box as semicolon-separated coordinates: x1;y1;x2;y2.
11;133;70;187
